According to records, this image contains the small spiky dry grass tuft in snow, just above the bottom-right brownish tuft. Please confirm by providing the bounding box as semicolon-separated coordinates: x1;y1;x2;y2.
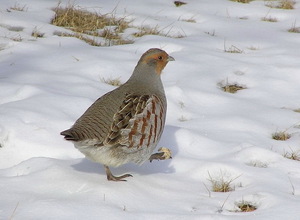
208;171;240;192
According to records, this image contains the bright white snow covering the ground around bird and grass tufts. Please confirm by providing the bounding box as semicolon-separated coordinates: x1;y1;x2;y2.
0;0;300;220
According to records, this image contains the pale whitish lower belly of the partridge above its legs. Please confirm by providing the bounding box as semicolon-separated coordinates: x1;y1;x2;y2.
74;143;156;167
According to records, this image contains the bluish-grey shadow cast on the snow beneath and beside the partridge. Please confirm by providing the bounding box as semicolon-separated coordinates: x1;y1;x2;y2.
72;125;178;175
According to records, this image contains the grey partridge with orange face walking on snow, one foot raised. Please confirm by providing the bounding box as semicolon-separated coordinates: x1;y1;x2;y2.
60;48;175;181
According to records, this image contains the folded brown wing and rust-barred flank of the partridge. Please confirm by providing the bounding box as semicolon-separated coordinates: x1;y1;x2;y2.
104;95;166;148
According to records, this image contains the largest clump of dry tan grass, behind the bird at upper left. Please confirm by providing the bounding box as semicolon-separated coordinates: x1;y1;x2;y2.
51;5;133;46
